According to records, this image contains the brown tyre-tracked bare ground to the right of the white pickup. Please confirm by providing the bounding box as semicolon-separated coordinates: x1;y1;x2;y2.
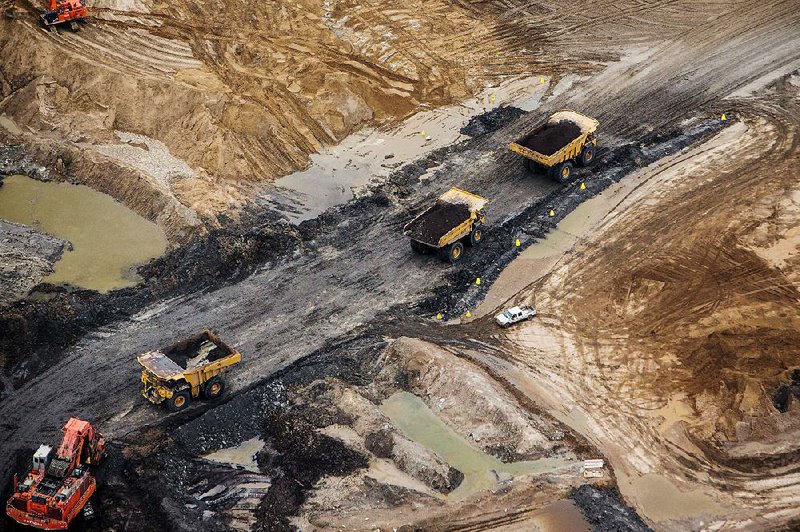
490;77;800;529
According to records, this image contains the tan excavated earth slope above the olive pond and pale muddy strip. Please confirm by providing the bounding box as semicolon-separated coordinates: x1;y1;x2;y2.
0;0;586;237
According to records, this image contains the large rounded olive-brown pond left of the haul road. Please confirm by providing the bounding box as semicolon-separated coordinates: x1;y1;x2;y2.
0;175;167;292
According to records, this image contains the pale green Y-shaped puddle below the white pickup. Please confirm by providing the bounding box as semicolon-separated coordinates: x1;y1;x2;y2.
381;392;575;500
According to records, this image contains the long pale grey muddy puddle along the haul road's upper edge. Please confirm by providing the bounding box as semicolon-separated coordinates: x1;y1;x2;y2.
262;76;549;222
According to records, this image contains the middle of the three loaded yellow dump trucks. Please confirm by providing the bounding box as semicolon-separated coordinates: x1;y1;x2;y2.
403;187;489;263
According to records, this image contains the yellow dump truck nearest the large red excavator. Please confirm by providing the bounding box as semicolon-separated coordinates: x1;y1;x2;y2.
136;330;242;412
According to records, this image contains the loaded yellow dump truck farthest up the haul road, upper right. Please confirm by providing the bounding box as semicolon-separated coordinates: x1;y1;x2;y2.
508;111;600;183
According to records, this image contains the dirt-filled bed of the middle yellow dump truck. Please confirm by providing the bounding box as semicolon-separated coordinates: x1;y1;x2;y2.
403;188;489;248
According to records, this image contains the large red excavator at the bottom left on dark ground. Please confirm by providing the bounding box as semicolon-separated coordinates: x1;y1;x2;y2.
6;418;106;530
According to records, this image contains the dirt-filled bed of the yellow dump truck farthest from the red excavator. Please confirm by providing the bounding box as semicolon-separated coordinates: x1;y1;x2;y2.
509;111;599;166
